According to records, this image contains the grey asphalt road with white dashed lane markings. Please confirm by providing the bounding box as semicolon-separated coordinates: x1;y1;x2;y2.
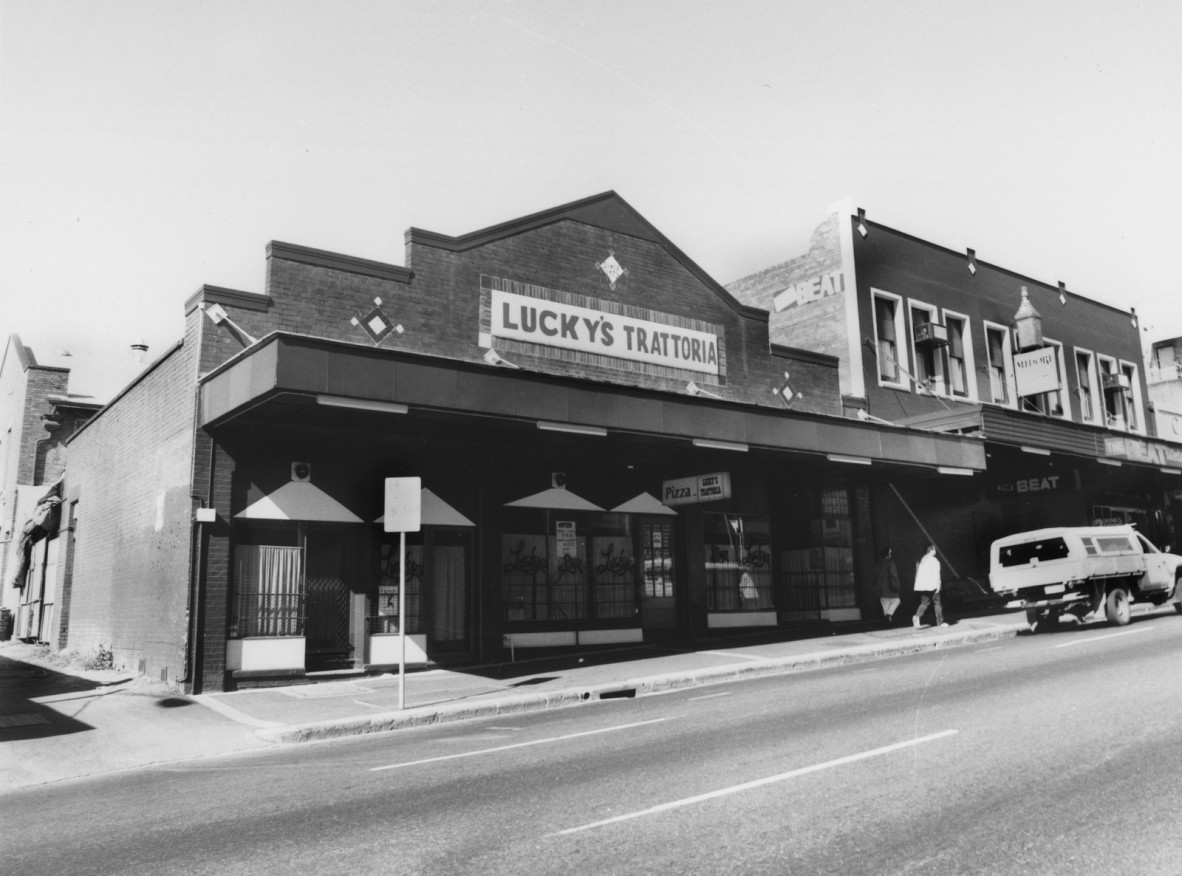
0;615;1182;876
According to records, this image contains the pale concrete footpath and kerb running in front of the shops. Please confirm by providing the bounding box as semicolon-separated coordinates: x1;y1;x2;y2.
0;612;1027;793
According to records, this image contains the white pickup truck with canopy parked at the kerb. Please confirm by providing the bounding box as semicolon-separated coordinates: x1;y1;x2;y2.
989;526;1182;629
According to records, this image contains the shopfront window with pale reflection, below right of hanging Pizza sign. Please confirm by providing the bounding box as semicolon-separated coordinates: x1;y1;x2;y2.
703;514;774;611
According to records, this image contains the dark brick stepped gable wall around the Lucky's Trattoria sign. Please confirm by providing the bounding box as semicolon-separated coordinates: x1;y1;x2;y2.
214;211;840;414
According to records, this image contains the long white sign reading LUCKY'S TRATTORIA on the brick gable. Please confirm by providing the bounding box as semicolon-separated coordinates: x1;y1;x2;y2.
492;290;719;375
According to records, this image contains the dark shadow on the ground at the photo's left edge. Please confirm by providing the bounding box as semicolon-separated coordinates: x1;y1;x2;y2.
0;655;111;745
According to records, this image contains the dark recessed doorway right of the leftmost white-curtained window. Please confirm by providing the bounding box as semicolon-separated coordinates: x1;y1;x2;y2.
304;530;353;671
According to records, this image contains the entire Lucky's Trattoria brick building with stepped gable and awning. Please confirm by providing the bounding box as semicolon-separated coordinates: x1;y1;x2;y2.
50;193;985;689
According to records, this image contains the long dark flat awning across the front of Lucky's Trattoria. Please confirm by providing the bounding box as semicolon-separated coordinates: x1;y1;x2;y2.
200;333;986;474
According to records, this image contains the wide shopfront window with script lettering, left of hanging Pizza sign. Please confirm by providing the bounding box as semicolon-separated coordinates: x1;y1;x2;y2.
501;511;647;622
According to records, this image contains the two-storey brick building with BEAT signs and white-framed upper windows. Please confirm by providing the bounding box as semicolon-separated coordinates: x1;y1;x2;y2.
728;205;1182;586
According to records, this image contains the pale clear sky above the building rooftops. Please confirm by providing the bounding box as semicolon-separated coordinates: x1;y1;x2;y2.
0;0;1182;380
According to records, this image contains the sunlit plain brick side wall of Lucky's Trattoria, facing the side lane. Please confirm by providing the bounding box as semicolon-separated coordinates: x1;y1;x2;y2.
64;345;195;680
